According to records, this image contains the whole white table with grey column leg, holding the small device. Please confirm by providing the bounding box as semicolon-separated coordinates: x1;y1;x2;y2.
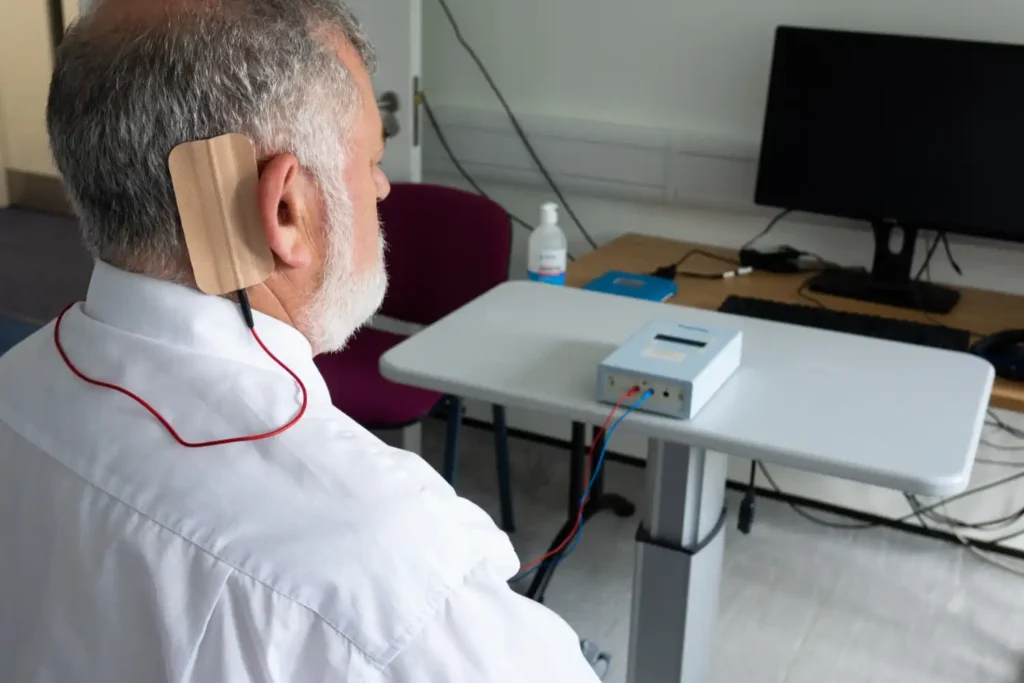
381;283;993;683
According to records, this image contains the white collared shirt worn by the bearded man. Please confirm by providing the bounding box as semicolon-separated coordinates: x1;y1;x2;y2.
0;263;596;683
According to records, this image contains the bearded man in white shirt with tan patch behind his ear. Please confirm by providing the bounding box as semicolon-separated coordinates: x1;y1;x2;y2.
0;0;595;683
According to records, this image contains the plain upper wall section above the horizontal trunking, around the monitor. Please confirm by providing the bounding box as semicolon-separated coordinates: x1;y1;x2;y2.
424;0;1024;143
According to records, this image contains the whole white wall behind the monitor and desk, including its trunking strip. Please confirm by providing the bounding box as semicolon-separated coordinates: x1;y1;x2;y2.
411;0;1024;540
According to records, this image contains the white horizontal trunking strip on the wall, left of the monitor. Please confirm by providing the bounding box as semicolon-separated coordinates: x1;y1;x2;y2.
423;104;758;210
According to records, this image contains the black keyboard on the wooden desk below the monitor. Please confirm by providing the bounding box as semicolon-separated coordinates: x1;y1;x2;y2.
719;296;971;351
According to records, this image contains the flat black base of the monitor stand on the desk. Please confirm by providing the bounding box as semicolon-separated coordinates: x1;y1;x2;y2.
807;268;961;313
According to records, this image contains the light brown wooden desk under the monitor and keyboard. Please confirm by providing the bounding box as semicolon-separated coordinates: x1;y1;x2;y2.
566;233;1024;413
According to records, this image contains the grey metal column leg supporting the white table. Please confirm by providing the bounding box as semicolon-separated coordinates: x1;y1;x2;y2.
628;440;727;683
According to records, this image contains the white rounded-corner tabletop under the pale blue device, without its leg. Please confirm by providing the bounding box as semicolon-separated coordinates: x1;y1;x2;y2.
381;283;992;496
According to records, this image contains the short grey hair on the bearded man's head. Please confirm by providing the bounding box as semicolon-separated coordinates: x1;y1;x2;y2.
46;0;374;279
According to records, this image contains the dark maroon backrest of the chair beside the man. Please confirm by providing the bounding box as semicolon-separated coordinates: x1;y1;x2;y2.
379;183;512;325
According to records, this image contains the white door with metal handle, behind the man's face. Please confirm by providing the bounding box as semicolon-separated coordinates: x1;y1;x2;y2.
348;0;423;182
